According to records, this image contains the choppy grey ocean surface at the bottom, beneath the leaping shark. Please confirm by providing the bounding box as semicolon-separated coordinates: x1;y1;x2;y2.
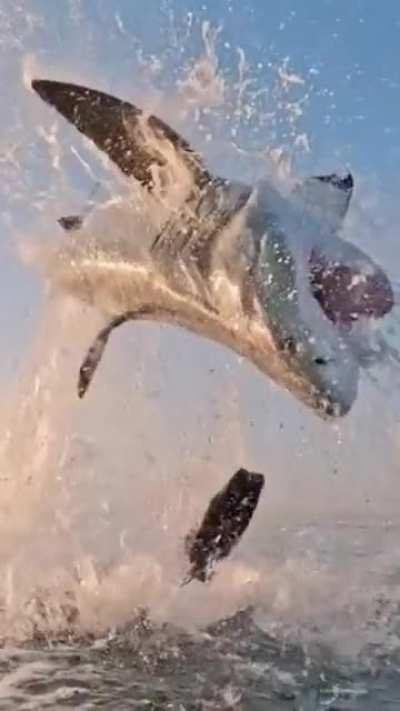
0;522;400;711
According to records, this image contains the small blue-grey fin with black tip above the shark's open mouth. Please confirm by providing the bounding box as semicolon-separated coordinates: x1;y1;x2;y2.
292;173;354;230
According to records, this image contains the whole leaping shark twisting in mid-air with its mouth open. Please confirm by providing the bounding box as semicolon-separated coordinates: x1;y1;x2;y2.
32;79;394;419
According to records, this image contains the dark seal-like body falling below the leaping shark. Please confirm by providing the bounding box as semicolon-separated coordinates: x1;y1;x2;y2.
184;469;265;583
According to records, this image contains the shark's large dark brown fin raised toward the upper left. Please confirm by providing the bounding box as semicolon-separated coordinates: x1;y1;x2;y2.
32;79;212;190
